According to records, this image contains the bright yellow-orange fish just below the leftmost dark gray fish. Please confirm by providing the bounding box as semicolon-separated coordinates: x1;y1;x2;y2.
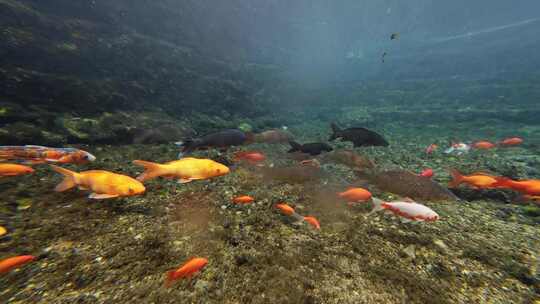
133;157;229;183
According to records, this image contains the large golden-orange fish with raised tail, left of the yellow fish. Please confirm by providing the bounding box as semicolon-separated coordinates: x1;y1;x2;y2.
51;165;146;199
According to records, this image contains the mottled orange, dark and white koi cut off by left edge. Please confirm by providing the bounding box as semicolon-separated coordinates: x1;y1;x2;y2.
0;145;96;164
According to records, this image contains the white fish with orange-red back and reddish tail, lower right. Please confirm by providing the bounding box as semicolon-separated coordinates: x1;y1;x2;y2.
369;197;439;223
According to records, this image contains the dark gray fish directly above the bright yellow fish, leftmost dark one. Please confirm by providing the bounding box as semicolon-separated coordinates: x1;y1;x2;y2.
180;129;248;153
